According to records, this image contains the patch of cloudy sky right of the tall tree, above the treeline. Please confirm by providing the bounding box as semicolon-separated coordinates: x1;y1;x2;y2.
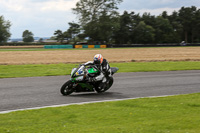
119;0;200;15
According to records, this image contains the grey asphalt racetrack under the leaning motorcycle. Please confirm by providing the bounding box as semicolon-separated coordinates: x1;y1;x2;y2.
0;70;200;112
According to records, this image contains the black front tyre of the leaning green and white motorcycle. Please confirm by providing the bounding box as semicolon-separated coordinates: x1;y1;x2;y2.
60;80;74;96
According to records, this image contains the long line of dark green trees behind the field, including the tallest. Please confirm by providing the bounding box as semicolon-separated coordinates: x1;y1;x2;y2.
54;0;200;44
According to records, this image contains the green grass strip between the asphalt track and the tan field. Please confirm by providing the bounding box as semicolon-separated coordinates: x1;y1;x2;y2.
0;61;200;78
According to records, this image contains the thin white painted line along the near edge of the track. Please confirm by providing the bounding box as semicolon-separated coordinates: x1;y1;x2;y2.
0;95;176;114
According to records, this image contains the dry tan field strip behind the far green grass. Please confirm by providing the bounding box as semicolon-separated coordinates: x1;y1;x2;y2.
0;47;200;65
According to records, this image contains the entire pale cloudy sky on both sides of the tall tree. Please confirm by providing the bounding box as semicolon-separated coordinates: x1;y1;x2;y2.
0;0;200;38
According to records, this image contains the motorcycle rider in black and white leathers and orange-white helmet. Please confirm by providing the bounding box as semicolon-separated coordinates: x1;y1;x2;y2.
84;54;111;82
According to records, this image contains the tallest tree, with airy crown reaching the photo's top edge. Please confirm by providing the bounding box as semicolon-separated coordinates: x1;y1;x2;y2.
73;0;123;41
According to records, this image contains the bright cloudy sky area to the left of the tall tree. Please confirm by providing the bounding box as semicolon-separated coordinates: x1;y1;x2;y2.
0;0;78;38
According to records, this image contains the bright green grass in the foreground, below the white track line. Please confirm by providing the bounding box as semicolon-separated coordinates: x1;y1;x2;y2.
0;93;200;133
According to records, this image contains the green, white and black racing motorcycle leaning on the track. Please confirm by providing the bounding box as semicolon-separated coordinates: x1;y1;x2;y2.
60;64;119;95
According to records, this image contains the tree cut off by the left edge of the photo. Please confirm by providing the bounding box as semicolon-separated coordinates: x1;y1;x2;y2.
0;16;11;42
